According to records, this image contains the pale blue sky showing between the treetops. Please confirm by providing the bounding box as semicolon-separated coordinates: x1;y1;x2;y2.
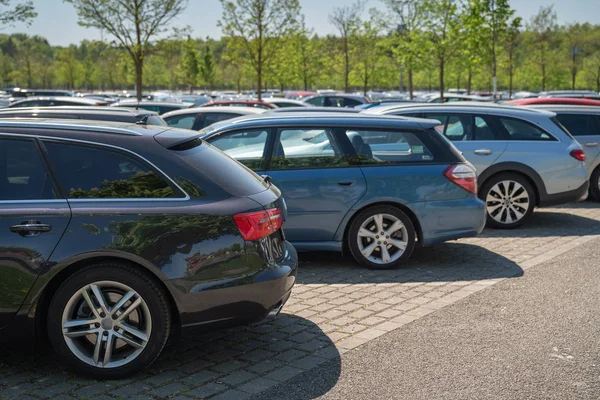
0;0;600;46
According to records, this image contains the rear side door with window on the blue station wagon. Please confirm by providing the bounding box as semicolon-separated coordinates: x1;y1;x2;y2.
267;127;366;244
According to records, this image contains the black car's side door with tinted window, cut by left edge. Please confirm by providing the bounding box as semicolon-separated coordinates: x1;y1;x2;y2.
0;134;71;328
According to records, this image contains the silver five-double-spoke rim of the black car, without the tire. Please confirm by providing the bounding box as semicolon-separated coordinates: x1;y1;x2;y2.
62;281;152;368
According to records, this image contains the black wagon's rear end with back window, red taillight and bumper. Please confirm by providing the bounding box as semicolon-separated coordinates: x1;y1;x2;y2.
155;130;298;326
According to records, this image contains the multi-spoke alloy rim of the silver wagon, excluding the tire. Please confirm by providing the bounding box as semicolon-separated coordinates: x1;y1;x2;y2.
485;180;531;224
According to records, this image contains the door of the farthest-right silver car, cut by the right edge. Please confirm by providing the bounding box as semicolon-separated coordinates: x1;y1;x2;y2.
556;112;600;171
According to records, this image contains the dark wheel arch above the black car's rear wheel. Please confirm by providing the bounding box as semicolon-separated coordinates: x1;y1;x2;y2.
31;255;180;337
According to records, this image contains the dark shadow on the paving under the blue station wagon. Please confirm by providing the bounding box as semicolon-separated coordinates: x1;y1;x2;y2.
297;242;523;284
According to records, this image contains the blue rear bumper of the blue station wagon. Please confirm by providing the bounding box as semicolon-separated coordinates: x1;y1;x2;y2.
409;195;486;246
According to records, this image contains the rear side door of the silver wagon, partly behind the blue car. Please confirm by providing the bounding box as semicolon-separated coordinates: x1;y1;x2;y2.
423;112;508;175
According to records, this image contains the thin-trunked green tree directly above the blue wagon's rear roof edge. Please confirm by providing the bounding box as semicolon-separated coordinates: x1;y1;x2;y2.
424;0;460;102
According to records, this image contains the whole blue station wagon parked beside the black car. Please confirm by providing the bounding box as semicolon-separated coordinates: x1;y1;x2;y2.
200;113;485;269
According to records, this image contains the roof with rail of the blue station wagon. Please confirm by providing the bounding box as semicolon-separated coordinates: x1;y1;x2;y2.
200;112;439;134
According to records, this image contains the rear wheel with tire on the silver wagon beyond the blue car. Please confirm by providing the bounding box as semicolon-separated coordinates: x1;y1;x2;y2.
479;173;535;229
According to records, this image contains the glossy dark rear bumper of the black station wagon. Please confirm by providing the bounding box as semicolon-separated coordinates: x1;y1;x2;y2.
175;242;298;329
